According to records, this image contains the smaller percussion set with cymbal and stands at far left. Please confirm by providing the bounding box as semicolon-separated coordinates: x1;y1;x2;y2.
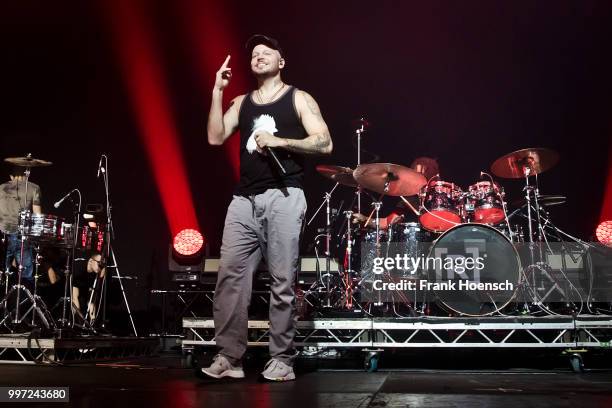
0;154;133;337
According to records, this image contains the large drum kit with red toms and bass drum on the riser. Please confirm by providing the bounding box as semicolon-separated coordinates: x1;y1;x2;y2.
308;132;588;317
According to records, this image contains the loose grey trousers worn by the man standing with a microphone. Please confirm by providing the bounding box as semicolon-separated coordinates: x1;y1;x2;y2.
213;187;306;365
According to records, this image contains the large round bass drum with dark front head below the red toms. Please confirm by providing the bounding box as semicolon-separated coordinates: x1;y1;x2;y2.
424;224;521;316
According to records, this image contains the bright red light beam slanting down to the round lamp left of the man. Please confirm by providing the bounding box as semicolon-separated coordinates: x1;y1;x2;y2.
102;0;199;234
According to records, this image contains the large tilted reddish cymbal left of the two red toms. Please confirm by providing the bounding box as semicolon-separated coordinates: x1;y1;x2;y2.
353;163;427;196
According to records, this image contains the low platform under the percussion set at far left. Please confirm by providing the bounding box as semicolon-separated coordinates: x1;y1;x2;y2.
0;333;159;364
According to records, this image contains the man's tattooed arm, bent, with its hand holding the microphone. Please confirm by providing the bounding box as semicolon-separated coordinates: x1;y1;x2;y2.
266;91;333;154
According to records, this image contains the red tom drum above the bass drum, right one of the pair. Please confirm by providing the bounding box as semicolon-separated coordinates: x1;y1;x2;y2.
466;181;505;225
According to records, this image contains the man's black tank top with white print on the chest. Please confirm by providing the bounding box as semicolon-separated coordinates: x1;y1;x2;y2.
236;87;306;196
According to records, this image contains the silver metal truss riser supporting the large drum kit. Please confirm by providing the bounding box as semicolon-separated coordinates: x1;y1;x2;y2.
182;318;612;351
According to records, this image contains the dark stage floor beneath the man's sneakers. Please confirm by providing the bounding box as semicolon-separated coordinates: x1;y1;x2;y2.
0;354;612;408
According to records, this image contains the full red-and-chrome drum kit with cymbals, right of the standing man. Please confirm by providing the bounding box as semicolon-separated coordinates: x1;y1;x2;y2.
307;140;612;316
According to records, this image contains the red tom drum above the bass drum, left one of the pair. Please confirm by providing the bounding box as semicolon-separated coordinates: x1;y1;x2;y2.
419;180;463;232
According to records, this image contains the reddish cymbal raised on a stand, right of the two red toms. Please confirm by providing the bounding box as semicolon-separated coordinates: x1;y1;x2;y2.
491;147;559;178
